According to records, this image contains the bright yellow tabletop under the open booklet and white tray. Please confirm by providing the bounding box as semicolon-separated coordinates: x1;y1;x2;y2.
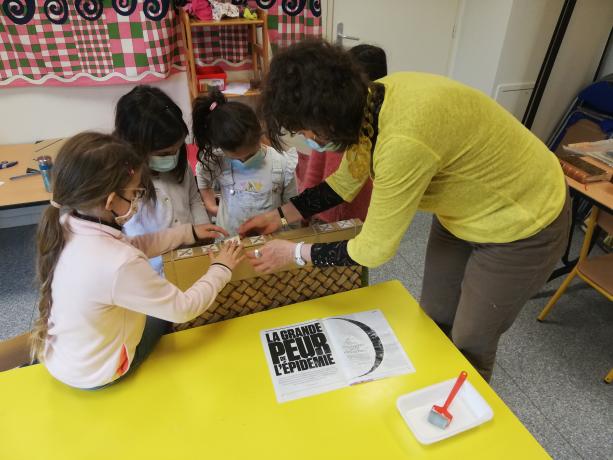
0;281;549;460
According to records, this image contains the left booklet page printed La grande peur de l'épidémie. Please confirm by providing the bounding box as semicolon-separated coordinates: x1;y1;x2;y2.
260;320;347;403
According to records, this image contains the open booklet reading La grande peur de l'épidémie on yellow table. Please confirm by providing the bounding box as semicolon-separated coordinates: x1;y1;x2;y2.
260;310;415;403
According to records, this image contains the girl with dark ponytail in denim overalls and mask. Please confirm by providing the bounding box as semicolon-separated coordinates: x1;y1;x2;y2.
192;90;298;235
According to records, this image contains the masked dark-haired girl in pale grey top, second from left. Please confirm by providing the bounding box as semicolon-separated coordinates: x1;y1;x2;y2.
115;85;210;274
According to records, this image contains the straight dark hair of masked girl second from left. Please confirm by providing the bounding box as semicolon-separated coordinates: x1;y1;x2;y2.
114;85;189;186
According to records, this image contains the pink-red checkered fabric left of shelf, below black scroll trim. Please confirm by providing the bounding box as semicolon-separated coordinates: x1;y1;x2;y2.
0;2;184;87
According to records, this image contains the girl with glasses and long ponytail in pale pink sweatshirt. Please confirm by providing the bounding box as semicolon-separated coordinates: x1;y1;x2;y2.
31;133;242;389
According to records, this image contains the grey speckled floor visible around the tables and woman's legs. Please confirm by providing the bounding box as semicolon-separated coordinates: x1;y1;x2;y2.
0;214;613;460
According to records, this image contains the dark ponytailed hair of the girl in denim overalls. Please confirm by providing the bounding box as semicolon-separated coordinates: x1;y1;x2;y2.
192;89;262;175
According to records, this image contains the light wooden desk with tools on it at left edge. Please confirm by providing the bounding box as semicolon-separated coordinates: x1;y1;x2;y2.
0;139;64;210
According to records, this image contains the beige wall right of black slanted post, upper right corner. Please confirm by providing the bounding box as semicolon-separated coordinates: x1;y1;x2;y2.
532;0;613;140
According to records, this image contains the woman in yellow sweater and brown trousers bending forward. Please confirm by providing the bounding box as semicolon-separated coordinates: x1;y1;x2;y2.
240;41;570;380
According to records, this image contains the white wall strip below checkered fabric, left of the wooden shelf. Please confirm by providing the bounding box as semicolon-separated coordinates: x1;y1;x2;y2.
0;72;191;144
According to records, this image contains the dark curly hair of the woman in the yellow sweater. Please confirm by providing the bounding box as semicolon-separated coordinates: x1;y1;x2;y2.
259;40;368;149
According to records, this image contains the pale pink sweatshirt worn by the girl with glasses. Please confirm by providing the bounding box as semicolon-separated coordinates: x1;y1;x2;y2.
43;215;232;388
